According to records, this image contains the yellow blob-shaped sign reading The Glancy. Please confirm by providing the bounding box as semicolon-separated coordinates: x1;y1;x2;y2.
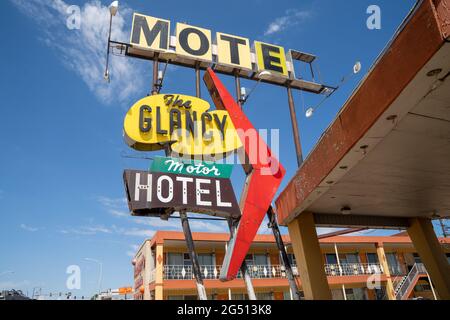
124;94;242;158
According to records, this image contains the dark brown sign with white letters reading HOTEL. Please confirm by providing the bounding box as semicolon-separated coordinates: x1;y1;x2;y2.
123;168;241;218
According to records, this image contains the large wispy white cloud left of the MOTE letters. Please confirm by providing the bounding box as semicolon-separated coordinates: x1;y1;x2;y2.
10;0;144;104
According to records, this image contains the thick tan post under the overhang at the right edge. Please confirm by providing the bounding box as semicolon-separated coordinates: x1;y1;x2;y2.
408;218;450;300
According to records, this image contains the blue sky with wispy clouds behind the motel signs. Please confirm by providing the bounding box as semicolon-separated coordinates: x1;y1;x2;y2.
0;0;428;296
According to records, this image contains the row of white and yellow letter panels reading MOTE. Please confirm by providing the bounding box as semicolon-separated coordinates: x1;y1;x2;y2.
130;13;295;78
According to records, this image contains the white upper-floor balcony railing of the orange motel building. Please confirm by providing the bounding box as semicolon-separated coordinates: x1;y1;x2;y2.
164;263;383;280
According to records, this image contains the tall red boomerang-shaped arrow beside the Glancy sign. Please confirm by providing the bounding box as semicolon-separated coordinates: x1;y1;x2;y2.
204;68;286;281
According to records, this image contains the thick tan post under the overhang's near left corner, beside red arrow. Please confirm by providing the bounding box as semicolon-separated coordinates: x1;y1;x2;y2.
288;212;331;300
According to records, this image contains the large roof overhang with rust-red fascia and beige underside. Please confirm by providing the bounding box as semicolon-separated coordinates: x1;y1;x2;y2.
276;0;450;225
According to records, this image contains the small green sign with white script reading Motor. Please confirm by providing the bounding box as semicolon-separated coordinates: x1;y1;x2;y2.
150;157;233;179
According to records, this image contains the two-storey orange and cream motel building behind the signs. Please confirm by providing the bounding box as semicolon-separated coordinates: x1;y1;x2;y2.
133;231;450;300
